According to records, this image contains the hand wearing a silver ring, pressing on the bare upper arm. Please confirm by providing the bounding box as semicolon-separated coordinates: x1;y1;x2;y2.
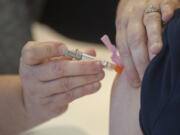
116;0;180;87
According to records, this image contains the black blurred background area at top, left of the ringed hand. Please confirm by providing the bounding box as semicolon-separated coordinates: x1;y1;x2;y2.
40;0;118;43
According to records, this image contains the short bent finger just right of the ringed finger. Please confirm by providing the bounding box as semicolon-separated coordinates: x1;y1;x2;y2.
160;1;175;23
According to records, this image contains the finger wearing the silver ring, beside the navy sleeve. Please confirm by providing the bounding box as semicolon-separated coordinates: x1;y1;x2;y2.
144;6;163;58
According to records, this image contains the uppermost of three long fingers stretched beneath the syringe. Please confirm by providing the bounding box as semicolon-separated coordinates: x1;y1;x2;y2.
32;60;102;81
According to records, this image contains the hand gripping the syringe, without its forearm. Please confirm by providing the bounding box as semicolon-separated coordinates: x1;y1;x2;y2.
20;42;104;125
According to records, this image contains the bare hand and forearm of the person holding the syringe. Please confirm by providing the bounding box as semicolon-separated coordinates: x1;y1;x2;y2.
0;42;104;135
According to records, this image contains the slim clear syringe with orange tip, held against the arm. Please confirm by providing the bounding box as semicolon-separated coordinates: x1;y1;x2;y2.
64;49;123;74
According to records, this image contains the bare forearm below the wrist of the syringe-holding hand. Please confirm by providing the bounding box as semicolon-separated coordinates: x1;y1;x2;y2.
0;75;28;135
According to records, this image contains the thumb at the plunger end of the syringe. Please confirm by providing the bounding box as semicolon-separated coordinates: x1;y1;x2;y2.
22;42;66;65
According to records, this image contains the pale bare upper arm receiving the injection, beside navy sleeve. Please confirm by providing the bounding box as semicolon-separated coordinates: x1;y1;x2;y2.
110;72;142;135
